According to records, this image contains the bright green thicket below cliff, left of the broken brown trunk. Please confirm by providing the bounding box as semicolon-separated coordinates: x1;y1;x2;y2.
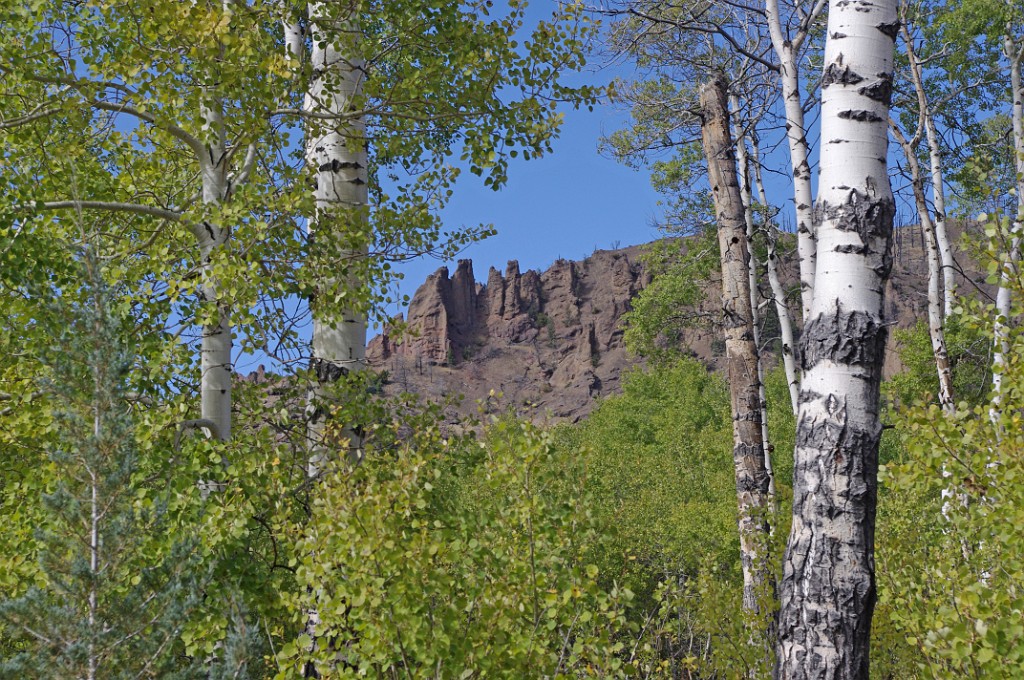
557;358;795;677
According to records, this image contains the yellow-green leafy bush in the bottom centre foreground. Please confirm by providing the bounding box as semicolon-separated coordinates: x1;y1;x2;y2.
279;414;632;678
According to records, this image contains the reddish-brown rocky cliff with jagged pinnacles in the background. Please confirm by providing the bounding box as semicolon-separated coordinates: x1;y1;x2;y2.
368;227;983;421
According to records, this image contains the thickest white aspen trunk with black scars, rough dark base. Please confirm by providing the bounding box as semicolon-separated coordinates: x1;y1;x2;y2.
775;0;899;680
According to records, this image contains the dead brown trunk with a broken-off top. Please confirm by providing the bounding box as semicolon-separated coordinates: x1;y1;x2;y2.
700;79;769;612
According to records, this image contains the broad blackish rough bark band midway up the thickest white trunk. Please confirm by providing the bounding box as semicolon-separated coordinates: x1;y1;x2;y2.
800;300;888;371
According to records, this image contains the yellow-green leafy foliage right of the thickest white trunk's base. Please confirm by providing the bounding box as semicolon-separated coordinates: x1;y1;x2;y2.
876;222;1024;678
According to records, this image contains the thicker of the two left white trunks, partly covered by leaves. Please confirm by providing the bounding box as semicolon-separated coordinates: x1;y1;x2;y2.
304;3;369;476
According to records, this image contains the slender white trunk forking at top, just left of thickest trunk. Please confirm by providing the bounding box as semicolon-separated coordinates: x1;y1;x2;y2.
765;0;823;324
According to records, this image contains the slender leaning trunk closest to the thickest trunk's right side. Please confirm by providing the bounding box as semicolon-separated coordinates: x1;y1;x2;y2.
889;119;956;414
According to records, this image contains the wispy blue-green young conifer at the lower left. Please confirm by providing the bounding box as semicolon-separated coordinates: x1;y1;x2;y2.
0;251;202;678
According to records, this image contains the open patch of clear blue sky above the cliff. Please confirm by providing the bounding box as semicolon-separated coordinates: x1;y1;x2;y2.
382;0;662;319
